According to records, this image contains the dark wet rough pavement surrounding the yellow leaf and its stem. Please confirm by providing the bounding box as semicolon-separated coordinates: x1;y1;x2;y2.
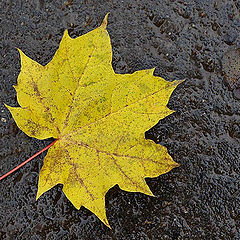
0;0;240;240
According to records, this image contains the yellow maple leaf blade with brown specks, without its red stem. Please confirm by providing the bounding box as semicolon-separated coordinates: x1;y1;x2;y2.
7;16;181;226
